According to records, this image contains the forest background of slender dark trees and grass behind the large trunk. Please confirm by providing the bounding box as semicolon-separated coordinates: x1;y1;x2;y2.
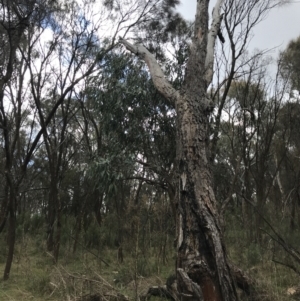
0;0;300;300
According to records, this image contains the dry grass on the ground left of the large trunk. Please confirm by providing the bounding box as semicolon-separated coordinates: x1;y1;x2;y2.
0;237;173;301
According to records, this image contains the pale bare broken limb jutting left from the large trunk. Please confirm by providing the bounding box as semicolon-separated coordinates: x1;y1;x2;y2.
119;37;179;104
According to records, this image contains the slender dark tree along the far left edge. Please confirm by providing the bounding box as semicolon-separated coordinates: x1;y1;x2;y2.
0;1;41;279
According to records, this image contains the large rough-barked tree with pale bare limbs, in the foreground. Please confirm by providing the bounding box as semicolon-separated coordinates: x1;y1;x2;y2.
120;0;238;301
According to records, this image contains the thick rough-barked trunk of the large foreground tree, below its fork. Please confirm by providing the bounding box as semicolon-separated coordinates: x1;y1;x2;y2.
177;91;237;301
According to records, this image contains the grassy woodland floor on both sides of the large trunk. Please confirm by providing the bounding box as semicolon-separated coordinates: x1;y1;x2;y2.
0;219;299;301
